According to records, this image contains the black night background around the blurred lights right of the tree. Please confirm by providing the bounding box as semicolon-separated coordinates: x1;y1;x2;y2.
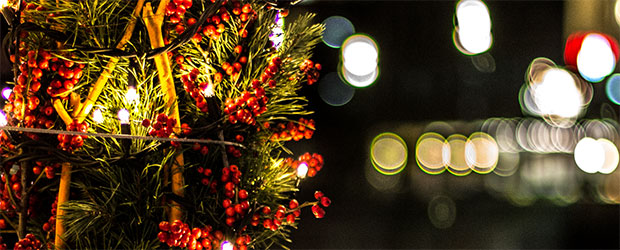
292;0;620;249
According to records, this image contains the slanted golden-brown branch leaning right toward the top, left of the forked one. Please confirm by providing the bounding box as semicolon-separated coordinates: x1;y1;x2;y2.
73;0;144;122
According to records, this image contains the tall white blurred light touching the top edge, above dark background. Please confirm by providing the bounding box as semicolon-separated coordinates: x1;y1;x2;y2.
452;0;493;55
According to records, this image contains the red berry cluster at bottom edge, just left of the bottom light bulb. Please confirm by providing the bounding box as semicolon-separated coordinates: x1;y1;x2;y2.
157;220;224;250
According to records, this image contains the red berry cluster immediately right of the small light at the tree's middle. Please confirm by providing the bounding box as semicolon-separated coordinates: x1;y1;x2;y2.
224;86;269;125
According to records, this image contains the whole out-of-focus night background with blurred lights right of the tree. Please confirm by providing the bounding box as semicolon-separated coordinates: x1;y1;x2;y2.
289;0;620;249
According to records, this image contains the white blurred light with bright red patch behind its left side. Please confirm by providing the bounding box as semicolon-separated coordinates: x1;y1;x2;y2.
577;33;616;82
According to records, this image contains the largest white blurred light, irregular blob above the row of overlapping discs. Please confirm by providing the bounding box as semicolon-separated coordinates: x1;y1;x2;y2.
533;68;584;118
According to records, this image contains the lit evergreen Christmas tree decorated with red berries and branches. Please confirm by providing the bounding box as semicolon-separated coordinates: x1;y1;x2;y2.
0;0;331;249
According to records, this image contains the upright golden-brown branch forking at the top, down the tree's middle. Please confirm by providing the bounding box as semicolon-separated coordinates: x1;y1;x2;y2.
142;0;185;222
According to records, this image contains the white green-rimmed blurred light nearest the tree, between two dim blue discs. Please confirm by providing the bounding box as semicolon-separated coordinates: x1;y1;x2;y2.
342;34;379;76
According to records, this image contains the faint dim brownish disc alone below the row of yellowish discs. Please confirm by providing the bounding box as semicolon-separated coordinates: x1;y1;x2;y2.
427;196;456;229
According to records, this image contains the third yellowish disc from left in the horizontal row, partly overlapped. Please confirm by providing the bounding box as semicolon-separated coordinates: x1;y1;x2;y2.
443;134;472;176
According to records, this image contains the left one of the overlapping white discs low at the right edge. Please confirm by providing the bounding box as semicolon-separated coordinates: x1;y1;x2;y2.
574;137;605;174
